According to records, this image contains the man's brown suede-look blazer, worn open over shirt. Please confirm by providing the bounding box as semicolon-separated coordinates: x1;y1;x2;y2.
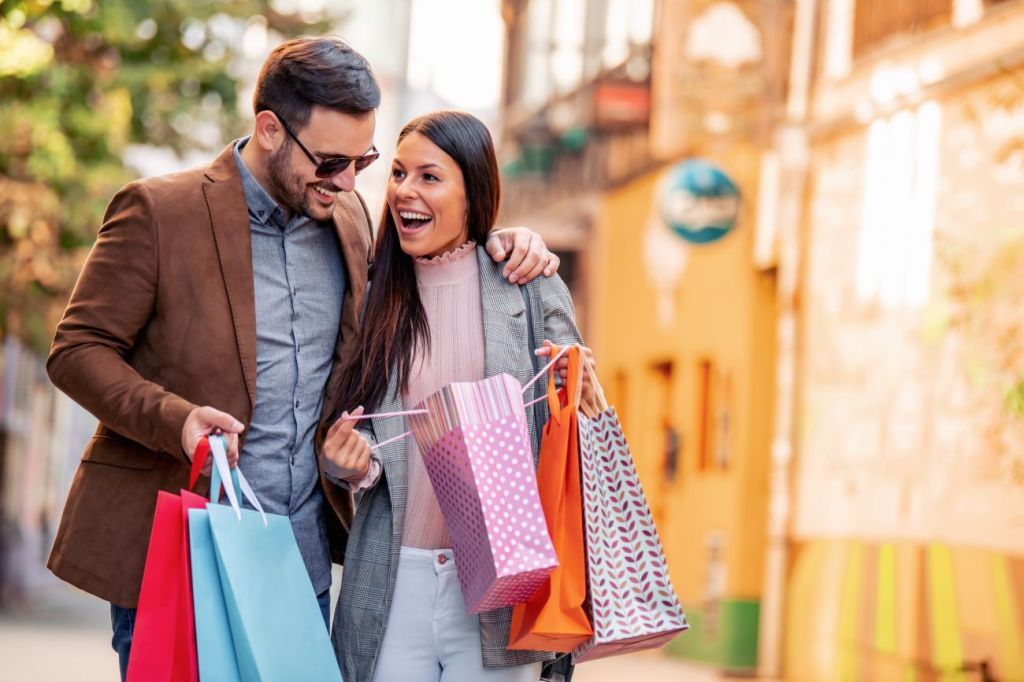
46;147;371;606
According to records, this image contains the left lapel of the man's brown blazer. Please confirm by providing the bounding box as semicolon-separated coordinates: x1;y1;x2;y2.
203;145;256;404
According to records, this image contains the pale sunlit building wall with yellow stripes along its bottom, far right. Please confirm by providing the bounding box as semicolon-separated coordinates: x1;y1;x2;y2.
783;0;1024;680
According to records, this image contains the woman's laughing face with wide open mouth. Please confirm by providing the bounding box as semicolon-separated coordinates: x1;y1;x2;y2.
387;132;468;257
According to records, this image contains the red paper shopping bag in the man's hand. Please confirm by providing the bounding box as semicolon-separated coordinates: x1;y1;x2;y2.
128;438;216;682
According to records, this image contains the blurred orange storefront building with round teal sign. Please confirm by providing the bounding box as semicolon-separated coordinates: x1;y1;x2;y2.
504;1;786;672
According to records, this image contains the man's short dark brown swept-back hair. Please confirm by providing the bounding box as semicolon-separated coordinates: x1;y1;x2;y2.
253;38;381;132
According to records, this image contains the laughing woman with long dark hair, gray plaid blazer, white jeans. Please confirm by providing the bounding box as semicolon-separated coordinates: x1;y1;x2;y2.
322;112;591;682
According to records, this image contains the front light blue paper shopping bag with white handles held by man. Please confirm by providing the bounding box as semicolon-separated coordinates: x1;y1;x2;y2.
196;438;341;682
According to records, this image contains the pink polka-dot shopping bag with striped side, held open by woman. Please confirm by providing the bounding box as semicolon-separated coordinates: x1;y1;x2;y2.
410;374;558;613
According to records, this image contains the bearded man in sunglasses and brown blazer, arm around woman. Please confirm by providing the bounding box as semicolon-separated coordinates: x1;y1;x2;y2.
47;39;558;678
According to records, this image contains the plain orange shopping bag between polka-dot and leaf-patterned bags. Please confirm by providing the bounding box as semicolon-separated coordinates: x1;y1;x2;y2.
509;346;594;651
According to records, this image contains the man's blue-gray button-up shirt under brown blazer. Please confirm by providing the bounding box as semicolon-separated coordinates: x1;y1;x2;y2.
234;137;346;594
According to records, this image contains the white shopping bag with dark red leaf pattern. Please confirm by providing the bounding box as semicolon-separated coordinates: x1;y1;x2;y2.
572;366;689;663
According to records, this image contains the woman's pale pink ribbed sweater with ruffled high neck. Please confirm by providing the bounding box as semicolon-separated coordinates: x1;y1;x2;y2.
401;242;484;549
